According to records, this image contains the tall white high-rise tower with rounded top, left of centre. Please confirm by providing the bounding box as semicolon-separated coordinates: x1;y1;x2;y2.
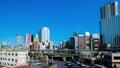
39;27;50;42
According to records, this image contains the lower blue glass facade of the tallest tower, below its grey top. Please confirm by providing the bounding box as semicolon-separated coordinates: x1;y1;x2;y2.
100;15;120;45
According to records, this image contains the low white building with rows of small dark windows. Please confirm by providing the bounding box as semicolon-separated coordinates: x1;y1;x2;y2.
0;51;28;67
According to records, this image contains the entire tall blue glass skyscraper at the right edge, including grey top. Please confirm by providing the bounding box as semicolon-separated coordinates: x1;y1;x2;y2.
100;1;120;45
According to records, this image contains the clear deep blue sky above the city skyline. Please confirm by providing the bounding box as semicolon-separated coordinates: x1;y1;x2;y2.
0;0;119;44
